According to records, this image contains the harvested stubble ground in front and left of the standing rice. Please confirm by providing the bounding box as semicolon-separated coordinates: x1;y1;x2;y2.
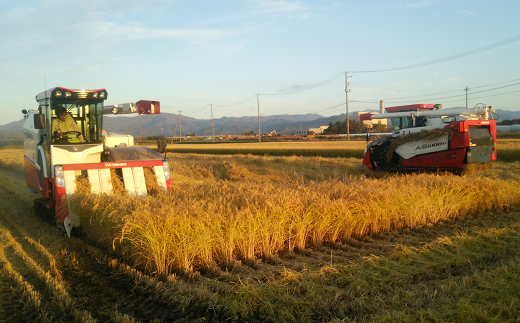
0;150;520;322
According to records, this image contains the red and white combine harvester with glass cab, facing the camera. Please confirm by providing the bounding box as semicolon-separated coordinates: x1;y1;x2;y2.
22;87;170;237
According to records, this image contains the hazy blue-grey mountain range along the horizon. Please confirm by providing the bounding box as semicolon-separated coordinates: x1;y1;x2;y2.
4;110;520;138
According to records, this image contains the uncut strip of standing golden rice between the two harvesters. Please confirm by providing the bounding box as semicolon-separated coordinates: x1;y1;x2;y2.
69;168;520;274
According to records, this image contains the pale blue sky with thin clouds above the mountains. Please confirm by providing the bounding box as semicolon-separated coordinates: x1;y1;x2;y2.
0;0;520;124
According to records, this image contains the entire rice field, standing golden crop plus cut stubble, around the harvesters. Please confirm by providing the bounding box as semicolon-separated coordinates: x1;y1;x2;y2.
0;140;520;322
